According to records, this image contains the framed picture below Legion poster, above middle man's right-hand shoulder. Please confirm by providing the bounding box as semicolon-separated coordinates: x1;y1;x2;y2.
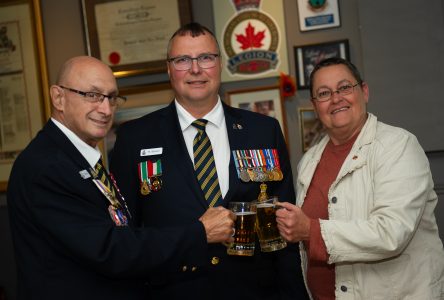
225;85;287;139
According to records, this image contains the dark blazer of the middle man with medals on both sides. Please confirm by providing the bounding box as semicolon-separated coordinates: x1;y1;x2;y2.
111;102;306;300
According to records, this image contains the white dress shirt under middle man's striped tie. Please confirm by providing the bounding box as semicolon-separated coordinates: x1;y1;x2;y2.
174;97;230;197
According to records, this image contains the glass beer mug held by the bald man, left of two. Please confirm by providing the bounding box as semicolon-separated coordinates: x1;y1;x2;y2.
227;202;256;256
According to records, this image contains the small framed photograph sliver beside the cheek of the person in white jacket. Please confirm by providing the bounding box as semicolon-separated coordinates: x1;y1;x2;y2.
299;108;325;152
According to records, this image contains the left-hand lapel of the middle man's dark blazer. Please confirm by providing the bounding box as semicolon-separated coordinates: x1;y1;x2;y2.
161;101;208;208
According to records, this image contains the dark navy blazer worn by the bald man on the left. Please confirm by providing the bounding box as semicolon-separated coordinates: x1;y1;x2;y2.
7;121;207;300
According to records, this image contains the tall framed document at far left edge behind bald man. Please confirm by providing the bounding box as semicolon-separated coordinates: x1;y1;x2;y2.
0;0;50;191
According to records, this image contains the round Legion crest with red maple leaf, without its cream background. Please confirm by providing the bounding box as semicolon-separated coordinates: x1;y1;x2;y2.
219;0;285;79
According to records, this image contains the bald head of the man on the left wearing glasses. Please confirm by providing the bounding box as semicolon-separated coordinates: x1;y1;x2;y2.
50;56;118;147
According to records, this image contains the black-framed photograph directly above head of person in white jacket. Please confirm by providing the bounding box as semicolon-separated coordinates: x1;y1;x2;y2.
294;40;350;89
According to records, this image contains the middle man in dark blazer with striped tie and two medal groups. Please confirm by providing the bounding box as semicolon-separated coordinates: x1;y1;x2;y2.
111;23;307;300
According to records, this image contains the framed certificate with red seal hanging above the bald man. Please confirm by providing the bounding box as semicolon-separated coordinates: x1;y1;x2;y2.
82;0;191;77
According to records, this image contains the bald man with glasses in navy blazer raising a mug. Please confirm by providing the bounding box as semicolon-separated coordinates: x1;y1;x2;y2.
7;56;235;300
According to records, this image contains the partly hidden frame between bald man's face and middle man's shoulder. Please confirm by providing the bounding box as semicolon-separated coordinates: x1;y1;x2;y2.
101;82;174;164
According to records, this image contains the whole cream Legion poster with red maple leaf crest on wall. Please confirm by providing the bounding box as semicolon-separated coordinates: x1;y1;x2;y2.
213;0;288;82
